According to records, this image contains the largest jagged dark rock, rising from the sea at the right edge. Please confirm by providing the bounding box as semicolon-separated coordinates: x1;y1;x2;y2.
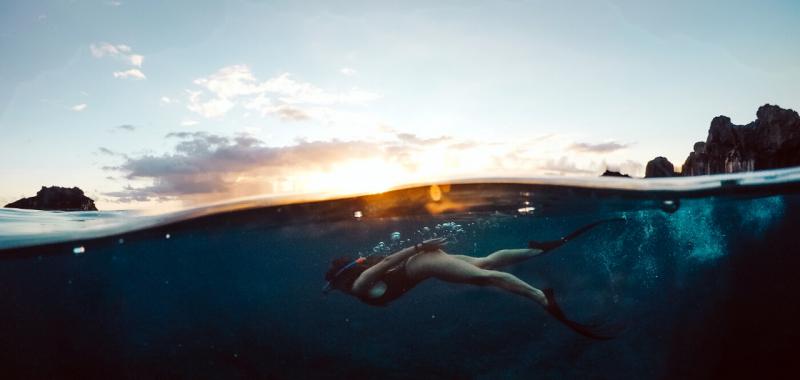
680;104;800;176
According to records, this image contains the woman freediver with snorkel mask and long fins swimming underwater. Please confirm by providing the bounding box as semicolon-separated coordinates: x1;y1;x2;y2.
323;218;622;340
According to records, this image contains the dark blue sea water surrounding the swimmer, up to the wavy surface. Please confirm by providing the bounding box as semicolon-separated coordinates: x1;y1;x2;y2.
0;169;800;379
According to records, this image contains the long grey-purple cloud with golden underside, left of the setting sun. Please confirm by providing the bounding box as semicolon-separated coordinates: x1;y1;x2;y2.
106;132;376;200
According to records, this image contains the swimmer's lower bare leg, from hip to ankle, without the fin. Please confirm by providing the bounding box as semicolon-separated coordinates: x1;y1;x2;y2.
406;251;547;308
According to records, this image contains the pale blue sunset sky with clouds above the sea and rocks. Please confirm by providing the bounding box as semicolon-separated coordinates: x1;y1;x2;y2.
0;0;800;210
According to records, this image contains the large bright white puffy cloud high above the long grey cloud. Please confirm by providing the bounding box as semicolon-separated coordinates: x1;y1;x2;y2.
187;65;379;120
